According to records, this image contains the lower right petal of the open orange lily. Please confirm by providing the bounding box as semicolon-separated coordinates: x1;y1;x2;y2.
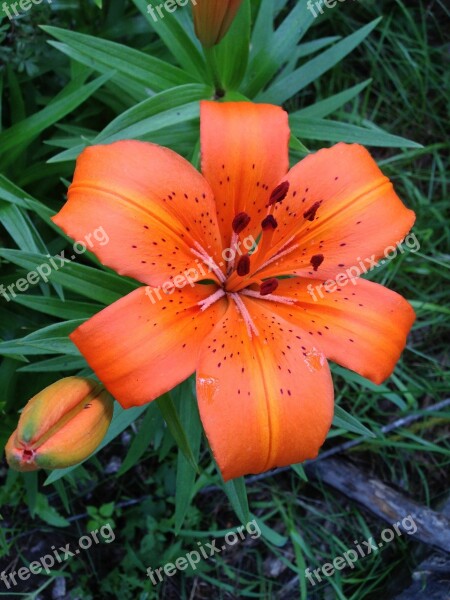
268;277;415;384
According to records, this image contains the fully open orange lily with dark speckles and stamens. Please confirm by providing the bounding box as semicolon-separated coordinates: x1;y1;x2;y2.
54;101;415;480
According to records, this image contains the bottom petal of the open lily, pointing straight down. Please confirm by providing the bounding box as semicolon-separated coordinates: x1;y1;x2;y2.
197;298;333;480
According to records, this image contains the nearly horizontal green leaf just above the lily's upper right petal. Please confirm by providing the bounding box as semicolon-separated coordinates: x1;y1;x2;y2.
290;116;422;148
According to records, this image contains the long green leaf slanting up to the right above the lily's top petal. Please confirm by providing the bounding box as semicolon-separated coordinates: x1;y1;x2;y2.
256;17;381;104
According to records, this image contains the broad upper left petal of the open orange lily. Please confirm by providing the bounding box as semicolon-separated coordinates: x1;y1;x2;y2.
53;141;221;286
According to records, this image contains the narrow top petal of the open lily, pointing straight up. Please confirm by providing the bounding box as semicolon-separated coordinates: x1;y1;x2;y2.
200;101;290;248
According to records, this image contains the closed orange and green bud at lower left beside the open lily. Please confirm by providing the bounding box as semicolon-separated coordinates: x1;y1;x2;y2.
5;377;114;471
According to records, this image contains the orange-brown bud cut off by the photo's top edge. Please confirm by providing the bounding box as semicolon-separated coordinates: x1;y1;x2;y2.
192;0;242;48
